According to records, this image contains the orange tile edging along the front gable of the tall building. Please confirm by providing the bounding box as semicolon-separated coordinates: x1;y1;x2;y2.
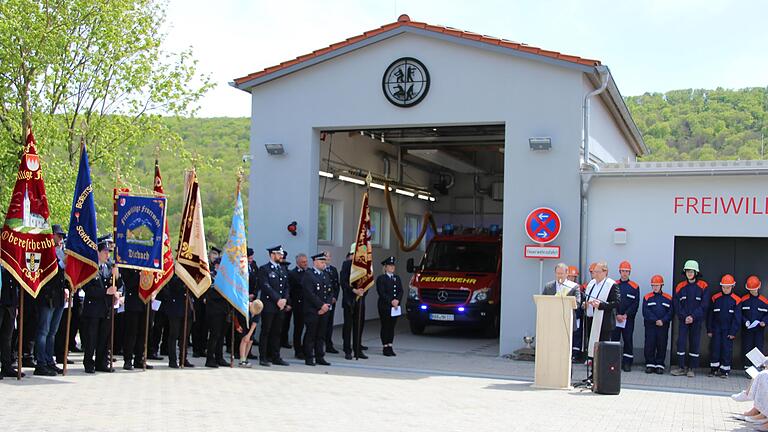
235;14;600;85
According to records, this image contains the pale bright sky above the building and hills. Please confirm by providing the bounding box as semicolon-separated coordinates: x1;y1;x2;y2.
163;0;768;117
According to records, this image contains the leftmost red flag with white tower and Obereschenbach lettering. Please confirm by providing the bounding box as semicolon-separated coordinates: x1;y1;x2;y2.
0;130;59;297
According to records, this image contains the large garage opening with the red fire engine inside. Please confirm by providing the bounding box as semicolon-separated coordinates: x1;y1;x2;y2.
318;124;505;346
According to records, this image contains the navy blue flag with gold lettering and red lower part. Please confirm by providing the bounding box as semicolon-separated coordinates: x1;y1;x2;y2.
65;146;99;290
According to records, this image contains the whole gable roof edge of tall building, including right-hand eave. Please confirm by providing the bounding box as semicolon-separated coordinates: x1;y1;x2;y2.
230;14;648;155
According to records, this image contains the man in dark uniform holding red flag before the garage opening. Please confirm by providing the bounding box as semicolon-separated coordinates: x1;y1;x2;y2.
339;243;368;360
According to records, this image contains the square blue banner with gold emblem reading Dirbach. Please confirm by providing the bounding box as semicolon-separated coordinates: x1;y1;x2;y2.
115;195;166;272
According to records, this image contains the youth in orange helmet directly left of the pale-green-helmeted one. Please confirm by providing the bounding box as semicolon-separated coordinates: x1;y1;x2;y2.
643;275;672;375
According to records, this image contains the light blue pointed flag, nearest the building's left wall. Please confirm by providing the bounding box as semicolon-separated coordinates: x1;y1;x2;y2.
214;188;250;322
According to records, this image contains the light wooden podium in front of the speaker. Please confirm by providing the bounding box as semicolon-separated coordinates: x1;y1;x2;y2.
533;295;576;389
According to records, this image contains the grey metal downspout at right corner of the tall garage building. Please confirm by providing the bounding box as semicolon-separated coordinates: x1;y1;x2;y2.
579;65;611;275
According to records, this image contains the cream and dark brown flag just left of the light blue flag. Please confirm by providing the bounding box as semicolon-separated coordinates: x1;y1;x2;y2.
175;171;211;298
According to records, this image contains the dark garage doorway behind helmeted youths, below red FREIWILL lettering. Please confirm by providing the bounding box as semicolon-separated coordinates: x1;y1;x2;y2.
667;237;768;368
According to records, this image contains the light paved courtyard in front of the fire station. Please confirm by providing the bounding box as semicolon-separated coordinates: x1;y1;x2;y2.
0;322;749;432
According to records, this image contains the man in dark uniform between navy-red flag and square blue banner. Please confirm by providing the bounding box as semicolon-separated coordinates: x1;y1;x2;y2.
80;242;118;374
